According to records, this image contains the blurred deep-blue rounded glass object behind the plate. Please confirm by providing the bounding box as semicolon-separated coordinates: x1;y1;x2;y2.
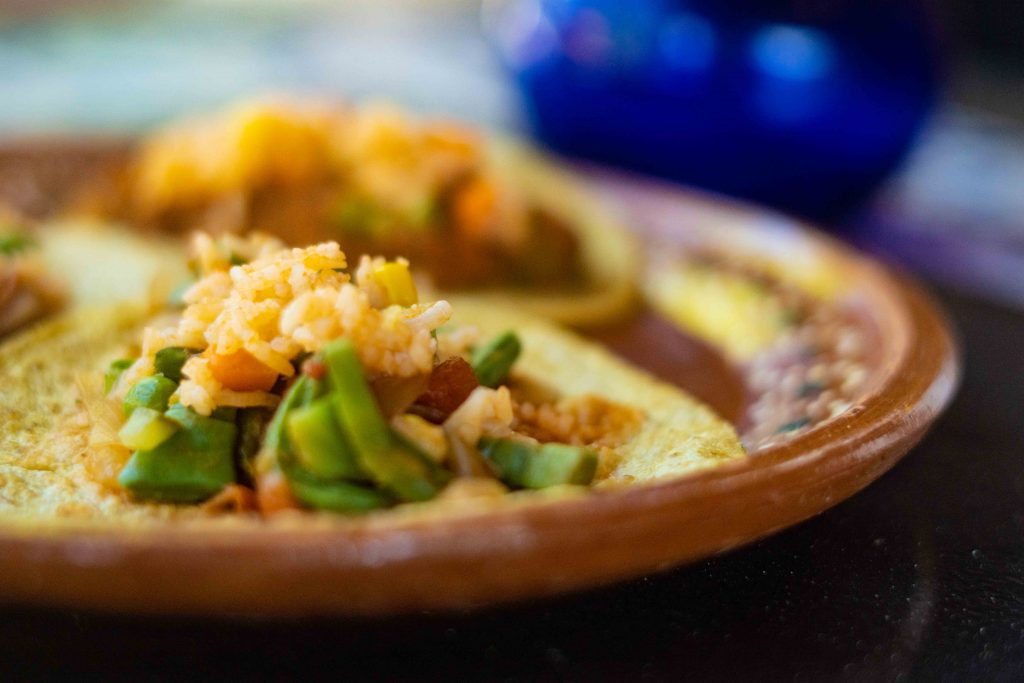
485;0;939;218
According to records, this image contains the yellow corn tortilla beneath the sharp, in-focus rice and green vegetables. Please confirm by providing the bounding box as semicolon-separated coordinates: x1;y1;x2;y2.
0;303;744;530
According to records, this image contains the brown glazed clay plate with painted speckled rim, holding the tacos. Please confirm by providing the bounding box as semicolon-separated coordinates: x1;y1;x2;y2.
0;140;958;615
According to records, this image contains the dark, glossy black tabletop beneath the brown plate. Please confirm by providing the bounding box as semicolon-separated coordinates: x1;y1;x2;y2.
0;280;1024;681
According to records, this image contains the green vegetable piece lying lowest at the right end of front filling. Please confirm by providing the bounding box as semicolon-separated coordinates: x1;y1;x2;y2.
480;438;597;488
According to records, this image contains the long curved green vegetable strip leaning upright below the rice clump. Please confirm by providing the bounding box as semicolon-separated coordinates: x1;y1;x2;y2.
324;339;437;501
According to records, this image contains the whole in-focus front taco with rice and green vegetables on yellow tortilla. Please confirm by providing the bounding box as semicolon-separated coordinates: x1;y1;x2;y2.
0;234;743;521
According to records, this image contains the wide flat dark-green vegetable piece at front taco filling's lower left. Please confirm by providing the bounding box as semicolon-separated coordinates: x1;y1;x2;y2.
118;403;238;503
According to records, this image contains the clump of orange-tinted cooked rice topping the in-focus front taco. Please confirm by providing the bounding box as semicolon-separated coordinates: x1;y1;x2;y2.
118;236;452;415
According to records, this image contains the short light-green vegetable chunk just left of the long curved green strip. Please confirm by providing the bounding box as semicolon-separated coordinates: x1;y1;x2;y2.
285;396;366;479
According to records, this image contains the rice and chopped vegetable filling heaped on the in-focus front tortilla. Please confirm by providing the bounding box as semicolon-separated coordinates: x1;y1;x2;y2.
93;233;641;513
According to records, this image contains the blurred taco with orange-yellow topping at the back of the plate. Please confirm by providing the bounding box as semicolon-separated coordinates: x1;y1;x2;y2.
84;98;639;324
